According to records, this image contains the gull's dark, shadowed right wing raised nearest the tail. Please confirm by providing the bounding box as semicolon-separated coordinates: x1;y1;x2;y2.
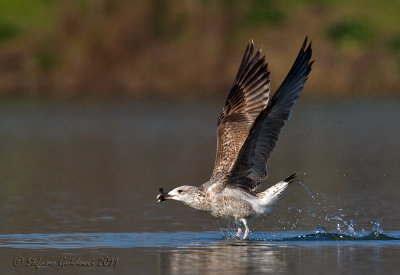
226;37;313;191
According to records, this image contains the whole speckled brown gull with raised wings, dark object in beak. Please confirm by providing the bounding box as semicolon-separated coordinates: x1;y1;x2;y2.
157;37;313;239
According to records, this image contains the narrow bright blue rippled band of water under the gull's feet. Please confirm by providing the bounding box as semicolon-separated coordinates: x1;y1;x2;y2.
0;228;400;249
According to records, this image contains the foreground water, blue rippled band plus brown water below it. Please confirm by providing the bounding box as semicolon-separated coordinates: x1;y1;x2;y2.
0;231;400;274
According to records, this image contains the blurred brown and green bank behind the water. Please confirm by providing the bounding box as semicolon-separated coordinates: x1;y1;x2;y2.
0;0;400;98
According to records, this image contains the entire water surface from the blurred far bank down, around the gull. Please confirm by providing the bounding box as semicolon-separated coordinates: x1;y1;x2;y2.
0;100;400;274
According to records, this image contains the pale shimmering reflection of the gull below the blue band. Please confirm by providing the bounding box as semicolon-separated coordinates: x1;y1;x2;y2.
158;244;288;274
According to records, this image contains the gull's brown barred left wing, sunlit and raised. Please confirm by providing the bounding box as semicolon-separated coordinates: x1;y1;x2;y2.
211;41;270;179
